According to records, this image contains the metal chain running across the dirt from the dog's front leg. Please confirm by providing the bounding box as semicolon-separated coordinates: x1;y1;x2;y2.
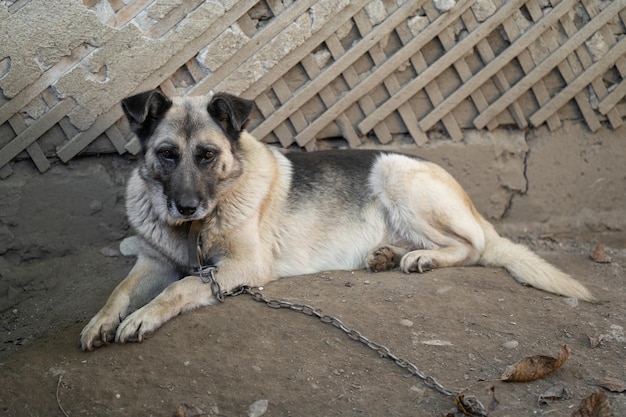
219;286;488;416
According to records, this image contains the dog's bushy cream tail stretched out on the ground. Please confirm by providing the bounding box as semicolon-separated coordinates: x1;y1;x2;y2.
478;219;595;301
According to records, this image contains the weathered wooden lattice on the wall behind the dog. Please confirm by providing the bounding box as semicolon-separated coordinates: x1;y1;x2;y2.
0;0;626;176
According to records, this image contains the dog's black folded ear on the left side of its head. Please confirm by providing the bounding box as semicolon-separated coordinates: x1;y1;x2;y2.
122;90;172;143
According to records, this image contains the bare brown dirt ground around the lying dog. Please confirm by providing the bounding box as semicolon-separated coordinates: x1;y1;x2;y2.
0;223;626;416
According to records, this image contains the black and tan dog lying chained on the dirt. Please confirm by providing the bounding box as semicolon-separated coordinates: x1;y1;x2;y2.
79;90;593;350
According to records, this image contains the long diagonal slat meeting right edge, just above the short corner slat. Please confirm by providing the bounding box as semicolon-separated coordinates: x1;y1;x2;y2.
530;35;626;126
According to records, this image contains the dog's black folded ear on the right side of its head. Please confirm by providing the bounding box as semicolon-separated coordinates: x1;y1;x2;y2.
207;93;254;140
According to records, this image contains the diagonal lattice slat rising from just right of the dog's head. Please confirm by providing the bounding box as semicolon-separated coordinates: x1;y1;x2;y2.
253;2;424;141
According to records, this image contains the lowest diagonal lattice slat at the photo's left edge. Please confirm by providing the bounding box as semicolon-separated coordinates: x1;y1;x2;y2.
0;98;76;167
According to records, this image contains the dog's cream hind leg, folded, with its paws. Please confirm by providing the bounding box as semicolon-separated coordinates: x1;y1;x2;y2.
367;154;485;273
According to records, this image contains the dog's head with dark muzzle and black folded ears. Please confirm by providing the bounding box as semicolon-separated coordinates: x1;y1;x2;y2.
122;90;253;223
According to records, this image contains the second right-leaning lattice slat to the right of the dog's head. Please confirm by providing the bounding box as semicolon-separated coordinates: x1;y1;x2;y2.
284;0;471;144
